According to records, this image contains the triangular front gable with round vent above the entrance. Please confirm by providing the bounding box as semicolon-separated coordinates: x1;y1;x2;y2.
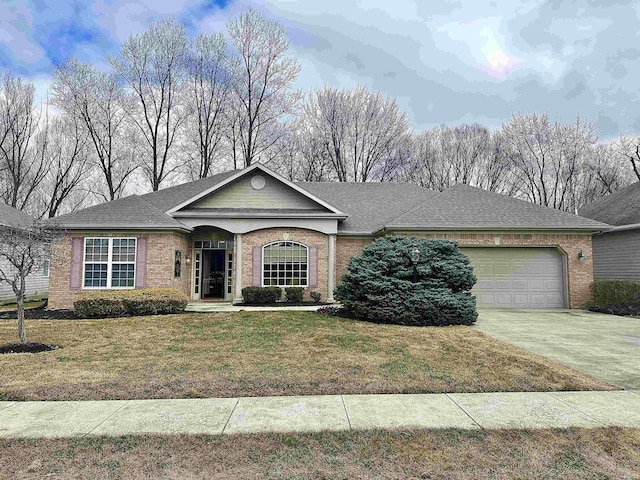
167;164;344;215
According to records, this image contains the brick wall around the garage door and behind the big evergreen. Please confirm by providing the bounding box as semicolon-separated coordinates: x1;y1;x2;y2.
336;232;593;308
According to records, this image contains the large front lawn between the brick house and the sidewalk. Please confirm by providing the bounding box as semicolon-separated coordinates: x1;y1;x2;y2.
0;312;613;400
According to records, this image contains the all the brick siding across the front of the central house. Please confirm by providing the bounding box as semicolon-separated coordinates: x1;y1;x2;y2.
49;228;593;309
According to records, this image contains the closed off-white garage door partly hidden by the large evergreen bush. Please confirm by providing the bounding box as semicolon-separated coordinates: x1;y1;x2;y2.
461;247;565;308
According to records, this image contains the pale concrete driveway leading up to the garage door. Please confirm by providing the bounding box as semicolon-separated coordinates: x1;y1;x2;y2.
475;310;640;390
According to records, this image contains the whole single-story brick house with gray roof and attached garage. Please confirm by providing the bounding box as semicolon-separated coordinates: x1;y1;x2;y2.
49;164;607;308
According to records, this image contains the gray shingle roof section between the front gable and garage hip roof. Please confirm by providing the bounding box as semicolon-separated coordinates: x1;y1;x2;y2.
296;182;436;233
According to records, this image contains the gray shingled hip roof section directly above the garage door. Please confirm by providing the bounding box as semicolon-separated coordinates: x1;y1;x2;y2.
386;185;608;230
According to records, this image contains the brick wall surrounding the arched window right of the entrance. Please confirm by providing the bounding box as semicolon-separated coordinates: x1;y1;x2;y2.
241;228;329;301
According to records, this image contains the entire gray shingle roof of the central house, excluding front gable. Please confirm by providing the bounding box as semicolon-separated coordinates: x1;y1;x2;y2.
52;170;607;235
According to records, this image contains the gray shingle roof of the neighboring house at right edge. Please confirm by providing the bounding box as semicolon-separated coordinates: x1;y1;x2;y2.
578;182;640;225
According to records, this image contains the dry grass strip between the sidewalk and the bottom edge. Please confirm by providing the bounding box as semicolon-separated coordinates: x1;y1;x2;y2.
0;428;640;480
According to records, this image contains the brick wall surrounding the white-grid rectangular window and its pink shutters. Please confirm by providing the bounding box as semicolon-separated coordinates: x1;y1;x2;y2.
49;231;191;309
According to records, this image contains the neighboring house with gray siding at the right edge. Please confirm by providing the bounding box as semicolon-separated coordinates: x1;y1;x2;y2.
579;182;640;282
